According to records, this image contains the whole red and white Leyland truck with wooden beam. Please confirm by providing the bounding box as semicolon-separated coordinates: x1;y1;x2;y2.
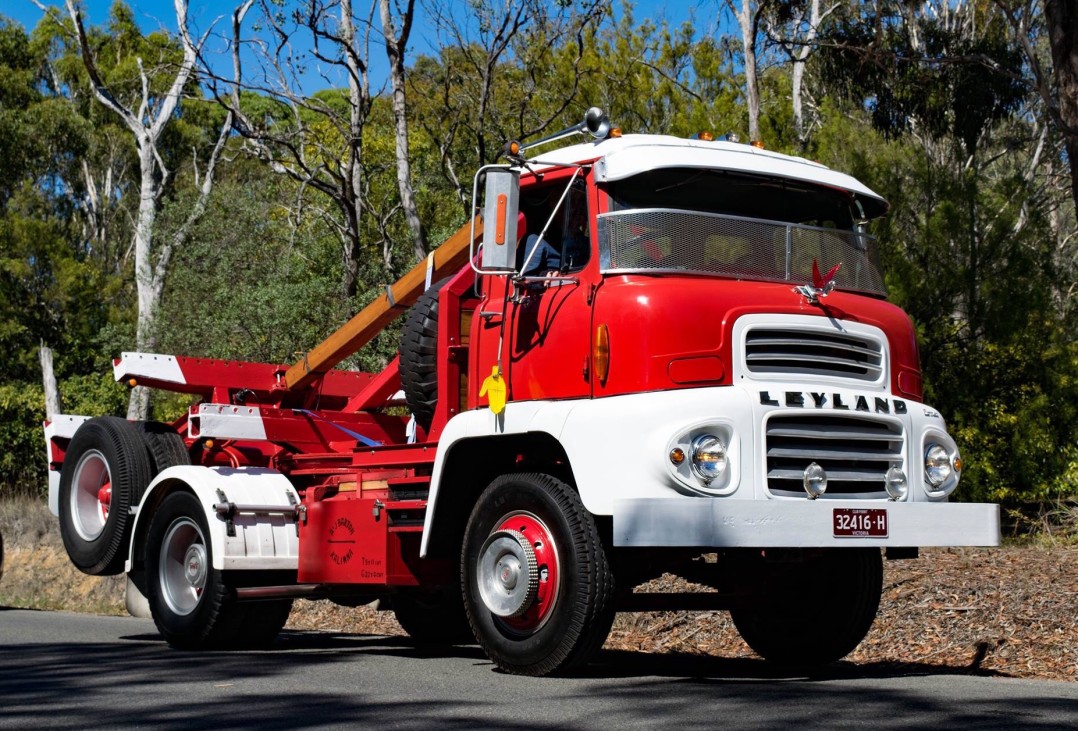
45;109;999;675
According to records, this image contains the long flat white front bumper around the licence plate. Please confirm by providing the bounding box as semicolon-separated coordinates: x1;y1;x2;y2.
613;497;999;548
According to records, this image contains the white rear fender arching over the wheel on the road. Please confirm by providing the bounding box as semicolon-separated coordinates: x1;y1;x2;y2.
126;466;300;573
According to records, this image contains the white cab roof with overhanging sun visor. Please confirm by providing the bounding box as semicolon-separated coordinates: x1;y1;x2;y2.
529;135;887;218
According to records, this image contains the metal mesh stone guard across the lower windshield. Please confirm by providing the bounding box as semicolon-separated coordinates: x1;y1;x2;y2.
598;208;885;294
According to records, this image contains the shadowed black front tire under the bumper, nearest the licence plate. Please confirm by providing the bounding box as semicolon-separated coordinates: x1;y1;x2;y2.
730;549;883;668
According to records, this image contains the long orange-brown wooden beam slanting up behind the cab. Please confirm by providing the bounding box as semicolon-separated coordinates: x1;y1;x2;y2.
285;219;483;390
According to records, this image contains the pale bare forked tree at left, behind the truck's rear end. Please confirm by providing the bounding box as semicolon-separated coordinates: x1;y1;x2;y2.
66;0;232;419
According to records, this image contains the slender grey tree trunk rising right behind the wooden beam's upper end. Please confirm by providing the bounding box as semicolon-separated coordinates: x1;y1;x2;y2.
378;0;427;260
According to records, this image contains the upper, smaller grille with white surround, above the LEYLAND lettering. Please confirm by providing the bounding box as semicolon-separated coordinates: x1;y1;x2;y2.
745;328;884;383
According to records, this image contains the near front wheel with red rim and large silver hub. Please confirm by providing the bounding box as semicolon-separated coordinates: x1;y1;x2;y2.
461;473;613;676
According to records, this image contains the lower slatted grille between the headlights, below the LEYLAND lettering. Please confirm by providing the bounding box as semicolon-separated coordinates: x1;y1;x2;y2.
765;414;902;499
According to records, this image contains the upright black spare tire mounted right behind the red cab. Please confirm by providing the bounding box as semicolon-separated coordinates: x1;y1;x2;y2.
399;279;448;430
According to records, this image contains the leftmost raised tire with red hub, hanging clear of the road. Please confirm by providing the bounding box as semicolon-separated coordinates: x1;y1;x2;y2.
59;416;151;576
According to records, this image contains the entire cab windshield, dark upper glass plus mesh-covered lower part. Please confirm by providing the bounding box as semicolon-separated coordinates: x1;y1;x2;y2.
598;168;885;294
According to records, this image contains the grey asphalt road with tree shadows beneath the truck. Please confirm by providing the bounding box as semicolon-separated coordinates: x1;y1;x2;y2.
0;608;1078;731
